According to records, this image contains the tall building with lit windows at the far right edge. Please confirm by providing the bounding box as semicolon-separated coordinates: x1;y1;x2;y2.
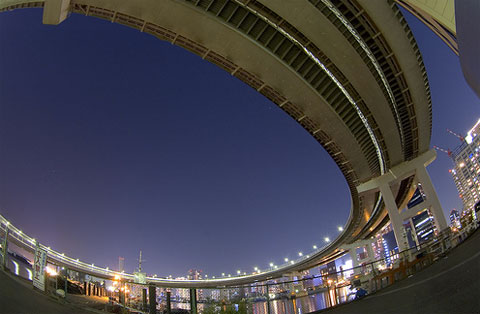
450;120;480;211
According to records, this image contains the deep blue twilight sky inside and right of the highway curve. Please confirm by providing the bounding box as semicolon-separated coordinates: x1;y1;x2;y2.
0;9;480;276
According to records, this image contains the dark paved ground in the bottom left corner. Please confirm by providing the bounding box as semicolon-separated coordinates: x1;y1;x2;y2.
0;271;99;314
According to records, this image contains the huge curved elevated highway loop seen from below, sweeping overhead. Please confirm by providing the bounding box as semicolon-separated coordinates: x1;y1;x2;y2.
0;0;432;287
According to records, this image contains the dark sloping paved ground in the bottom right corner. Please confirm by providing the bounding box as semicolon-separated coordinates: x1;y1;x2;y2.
321;230;480;314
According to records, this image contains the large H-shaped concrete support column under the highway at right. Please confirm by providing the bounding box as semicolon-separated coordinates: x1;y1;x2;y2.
357;150;448;251
